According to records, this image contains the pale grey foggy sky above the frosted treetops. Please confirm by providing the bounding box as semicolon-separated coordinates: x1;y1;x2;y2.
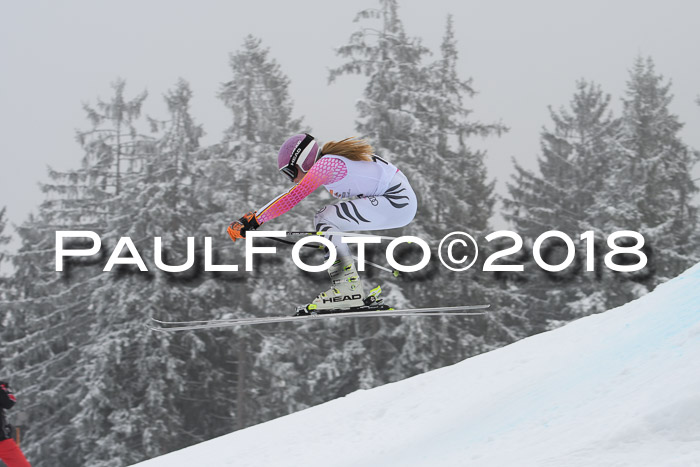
0;0;700;241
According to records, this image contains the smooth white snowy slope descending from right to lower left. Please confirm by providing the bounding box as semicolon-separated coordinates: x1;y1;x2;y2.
133;264;700;467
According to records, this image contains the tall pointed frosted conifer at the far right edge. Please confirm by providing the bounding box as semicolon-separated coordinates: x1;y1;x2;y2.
599;57;700;287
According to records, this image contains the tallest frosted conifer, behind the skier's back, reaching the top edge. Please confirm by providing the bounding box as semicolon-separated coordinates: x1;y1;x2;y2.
318;0;429;397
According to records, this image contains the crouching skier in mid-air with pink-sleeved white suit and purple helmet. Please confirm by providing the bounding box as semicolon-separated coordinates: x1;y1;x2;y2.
228;133;417;310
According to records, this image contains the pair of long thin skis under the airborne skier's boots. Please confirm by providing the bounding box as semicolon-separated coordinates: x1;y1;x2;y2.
148;305;489;332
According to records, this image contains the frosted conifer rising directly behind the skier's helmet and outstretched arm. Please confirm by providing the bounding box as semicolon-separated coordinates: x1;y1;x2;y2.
211;35;304;227
